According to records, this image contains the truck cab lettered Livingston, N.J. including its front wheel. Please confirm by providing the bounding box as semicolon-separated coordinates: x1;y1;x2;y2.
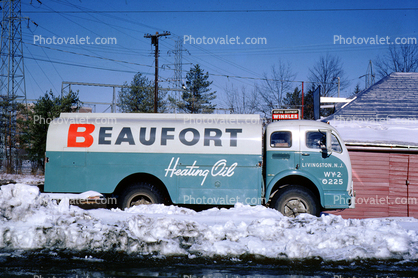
264;120;354;216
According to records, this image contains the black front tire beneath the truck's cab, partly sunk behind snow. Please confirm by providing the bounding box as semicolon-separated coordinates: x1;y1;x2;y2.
271;185;321;217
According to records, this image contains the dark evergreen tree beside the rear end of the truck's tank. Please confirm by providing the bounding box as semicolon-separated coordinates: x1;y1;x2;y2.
18;91;80;171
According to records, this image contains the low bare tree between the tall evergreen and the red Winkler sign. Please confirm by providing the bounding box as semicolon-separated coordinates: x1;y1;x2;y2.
224;82;259;114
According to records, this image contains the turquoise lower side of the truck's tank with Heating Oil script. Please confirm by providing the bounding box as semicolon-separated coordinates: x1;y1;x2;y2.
45;152;262;204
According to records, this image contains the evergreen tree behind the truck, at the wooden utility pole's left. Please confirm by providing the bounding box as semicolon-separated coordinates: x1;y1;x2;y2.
117;73;167;113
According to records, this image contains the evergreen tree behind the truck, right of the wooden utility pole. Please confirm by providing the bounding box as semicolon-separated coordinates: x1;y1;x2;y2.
169;65;216;114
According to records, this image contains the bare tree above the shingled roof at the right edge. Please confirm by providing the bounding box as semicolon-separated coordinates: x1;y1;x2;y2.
375;44;418;78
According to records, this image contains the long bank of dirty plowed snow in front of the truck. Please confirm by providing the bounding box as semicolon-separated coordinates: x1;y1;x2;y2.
0;184;418;260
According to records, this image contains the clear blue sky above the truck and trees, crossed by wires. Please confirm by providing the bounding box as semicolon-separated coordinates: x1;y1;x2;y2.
18;0;418;112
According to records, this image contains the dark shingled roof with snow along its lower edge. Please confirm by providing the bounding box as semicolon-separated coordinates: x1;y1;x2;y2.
322;72;418;148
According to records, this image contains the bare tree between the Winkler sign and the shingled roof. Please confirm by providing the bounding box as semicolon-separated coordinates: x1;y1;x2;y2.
309;53;349;97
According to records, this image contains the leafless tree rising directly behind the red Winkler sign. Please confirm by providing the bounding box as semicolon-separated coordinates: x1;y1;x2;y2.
256;60;296;115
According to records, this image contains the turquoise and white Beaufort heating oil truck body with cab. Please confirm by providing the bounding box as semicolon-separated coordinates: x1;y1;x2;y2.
44;113;354;213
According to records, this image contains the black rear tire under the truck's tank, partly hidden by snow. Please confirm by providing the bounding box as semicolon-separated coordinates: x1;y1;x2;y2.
119;183;164;209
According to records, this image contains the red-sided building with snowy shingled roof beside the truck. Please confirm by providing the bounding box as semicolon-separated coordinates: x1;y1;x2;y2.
326;73;418;218
